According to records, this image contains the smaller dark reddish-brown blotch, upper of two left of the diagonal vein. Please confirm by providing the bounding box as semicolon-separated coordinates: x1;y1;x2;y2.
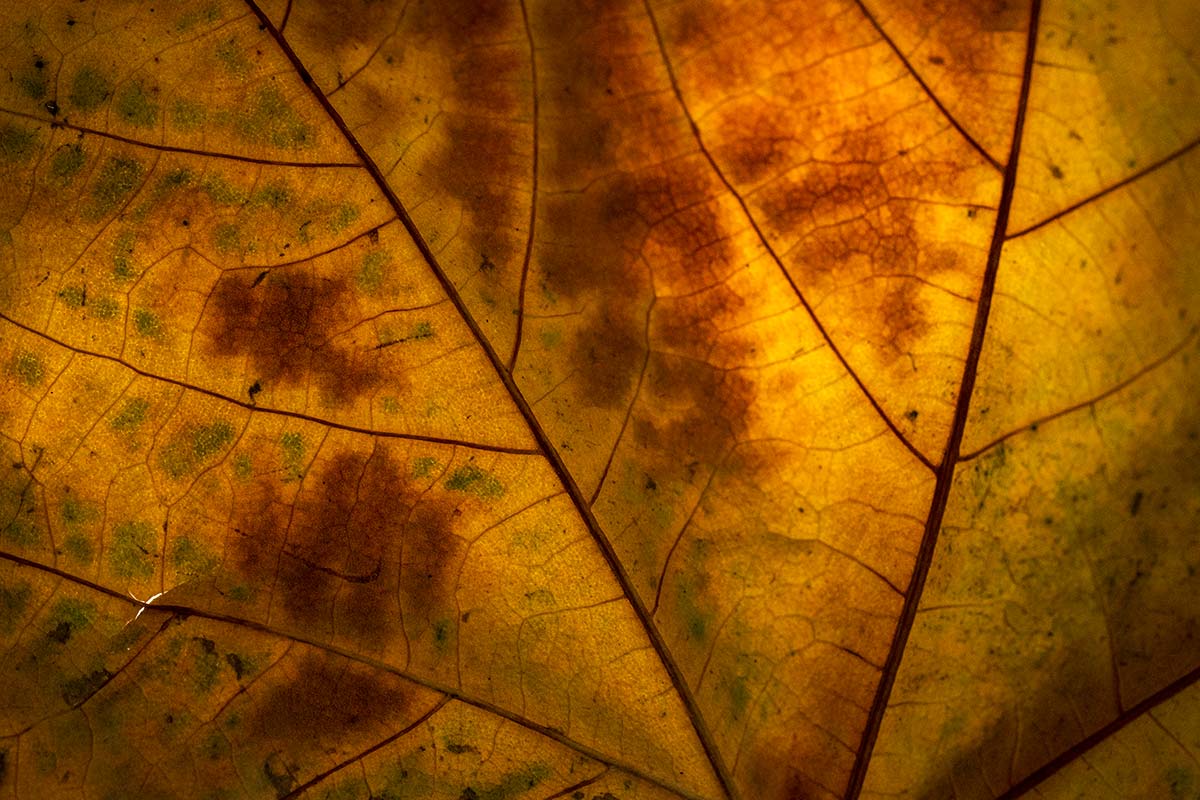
198;269;381;404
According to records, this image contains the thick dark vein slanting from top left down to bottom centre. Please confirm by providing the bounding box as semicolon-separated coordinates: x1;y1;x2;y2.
245;0;738;800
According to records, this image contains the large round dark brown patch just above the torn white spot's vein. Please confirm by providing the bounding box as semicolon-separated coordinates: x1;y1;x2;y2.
229;444;466;651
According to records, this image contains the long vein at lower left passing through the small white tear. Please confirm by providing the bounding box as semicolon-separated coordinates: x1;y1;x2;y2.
0;551;701;800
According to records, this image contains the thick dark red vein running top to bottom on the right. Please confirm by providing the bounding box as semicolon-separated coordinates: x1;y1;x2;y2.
845;0;1042;800
